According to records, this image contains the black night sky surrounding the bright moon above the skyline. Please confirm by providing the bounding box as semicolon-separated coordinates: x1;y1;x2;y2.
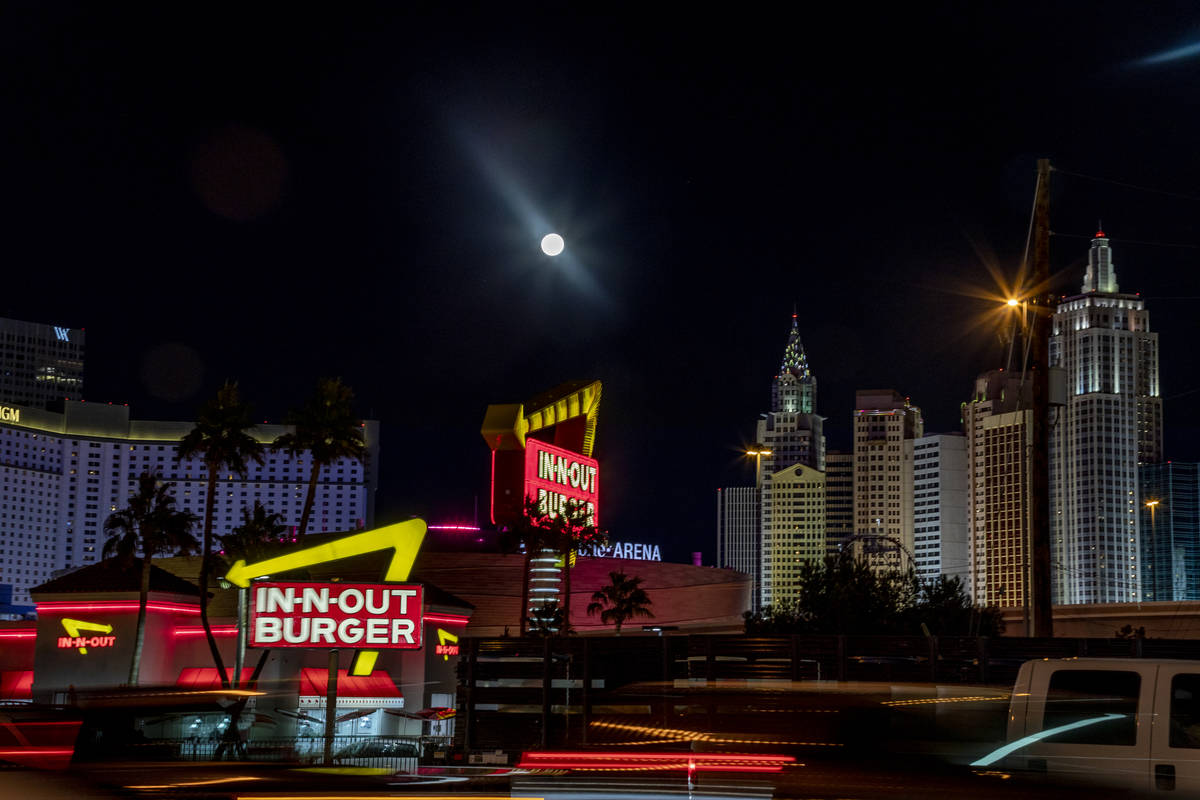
7;2;1200;563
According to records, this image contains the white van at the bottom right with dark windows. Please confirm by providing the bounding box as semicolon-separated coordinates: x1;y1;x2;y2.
974;658;1200;795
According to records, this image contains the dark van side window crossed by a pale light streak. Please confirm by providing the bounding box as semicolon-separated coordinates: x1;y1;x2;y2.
1042;669;1141;746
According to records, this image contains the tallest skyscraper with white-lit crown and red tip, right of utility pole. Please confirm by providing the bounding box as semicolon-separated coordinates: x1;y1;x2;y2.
1050;231;1163;603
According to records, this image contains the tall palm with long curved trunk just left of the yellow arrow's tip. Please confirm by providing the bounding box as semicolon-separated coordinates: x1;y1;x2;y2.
179;380;263;688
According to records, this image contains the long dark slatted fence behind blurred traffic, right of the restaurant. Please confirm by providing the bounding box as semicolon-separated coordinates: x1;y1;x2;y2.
456;634;1200;752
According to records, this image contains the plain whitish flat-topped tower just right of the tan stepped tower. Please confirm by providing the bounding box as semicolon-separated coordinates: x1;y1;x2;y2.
912;433;967;581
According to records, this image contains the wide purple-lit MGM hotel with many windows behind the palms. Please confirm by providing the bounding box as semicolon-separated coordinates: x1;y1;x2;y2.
0;401;379;606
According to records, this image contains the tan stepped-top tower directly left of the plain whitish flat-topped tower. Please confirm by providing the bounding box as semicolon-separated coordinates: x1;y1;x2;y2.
853;389;925;570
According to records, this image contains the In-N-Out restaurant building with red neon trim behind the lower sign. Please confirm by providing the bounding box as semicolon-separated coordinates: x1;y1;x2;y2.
0;522;473;751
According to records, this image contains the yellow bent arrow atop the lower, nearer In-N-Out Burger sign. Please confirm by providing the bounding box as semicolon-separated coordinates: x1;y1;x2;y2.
226;519;425;589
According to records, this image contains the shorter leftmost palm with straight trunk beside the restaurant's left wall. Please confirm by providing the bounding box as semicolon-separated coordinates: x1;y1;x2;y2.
103;473;198;686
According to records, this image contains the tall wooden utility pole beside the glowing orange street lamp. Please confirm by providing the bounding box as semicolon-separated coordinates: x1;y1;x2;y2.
1030;158;1054;637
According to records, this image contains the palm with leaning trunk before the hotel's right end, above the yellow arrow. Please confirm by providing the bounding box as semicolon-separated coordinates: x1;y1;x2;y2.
275;378;366;540
